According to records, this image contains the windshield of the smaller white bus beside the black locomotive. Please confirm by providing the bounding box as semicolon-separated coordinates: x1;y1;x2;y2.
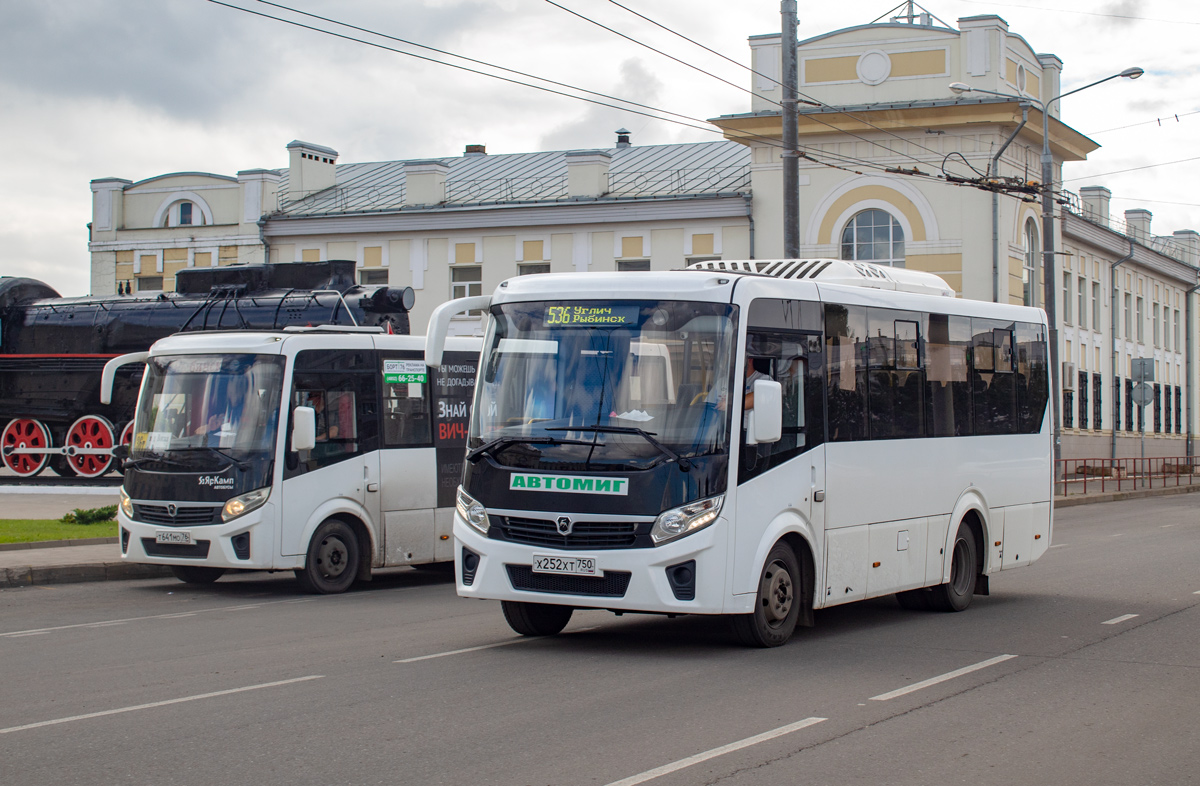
130;354;283;470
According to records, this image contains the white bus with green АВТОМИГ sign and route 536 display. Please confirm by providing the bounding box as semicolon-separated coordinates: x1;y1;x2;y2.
426;259;1051;646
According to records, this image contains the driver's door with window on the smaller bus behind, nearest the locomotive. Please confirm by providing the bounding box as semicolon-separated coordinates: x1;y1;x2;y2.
278;347;379;556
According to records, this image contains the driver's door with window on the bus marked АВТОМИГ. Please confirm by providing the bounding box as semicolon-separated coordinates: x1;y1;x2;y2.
734;300;826;592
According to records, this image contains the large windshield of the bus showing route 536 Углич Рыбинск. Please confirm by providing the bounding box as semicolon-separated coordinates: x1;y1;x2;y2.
468;300;736;469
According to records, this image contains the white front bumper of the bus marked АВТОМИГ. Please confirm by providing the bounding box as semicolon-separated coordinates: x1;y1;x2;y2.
454;514;726;614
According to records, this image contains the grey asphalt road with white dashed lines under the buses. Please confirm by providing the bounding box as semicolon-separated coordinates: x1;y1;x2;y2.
0;496;1200;786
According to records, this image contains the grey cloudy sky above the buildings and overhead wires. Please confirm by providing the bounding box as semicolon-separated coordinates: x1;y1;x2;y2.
0;0;1200;295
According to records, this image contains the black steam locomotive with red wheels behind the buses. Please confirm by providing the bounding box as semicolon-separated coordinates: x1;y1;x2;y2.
0;260;414;478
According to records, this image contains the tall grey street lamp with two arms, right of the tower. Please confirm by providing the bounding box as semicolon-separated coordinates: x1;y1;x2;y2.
950;66;1146;473
